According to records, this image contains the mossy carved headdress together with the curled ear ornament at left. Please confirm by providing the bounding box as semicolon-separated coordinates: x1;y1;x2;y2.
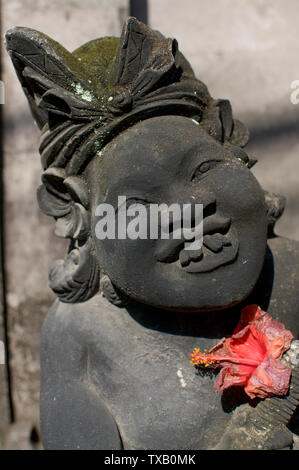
6;18;264;302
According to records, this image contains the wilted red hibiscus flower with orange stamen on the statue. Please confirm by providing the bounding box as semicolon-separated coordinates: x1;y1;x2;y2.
190;305;293;398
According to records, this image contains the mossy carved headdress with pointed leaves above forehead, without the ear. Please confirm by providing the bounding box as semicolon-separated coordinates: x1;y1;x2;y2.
6;18;247;175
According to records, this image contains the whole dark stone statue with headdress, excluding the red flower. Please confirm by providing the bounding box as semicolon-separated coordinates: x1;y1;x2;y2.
6;18;299;450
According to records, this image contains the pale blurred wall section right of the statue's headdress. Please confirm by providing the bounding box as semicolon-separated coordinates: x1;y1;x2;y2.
148;0;299;240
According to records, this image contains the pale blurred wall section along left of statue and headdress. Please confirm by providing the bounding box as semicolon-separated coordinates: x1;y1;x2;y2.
0;0;129;444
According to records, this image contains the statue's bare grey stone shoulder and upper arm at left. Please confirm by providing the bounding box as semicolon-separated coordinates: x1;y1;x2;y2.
40;301;122;450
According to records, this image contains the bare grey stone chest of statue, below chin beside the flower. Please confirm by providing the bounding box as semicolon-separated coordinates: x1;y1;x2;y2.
87;310;234;450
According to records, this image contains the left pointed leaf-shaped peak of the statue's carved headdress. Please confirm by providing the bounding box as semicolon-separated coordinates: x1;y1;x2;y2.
5;27;99;129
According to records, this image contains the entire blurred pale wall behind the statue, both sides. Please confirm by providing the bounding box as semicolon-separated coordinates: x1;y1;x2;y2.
0;0;299;448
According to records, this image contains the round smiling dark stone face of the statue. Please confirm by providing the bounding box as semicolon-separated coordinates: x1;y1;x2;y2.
92;116;267;311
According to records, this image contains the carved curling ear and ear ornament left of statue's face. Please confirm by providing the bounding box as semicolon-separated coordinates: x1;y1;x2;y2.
37;167;99;303
